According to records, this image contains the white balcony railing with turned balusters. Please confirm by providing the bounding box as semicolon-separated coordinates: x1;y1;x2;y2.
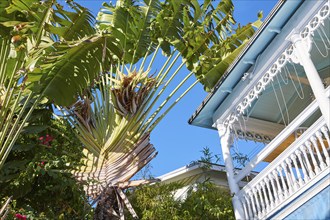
238;117;330;219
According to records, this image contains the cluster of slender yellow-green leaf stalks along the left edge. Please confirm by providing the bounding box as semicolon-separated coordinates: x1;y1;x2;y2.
0;37;32;169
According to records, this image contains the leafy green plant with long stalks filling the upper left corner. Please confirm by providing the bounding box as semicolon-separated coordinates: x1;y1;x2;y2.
0;0;104;168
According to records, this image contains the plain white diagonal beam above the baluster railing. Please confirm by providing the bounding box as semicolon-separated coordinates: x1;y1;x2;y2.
235;86;330;183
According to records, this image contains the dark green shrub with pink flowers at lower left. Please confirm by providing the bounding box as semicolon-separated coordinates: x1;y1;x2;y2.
0;107;92;219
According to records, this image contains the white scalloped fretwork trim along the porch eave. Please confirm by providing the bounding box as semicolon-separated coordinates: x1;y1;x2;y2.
223;1;330;128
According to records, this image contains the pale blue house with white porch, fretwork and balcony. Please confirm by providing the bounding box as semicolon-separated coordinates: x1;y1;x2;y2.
189;0;330;219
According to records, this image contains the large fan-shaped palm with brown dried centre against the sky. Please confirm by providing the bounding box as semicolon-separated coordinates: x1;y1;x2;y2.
59;0;262;219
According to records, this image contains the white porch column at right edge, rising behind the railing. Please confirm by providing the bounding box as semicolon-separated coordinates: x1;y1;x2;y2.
290;33;330;128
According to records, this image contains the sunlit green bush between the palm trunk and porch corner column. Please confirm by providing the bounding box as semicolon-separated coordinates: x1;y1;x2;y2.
127;180;234;220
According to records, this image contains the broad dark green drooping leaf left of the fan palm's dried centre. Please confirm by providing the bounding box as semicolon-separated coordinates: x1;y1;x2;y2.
28;36;109;106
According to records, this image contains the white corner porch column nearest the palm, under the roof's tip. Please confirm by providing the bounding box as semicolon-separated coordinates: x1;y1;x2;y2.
217;124;245;219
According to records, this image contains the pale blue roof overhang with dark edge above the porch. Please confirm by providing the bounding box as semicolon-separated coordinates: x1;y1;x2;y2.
188;0;304;129
